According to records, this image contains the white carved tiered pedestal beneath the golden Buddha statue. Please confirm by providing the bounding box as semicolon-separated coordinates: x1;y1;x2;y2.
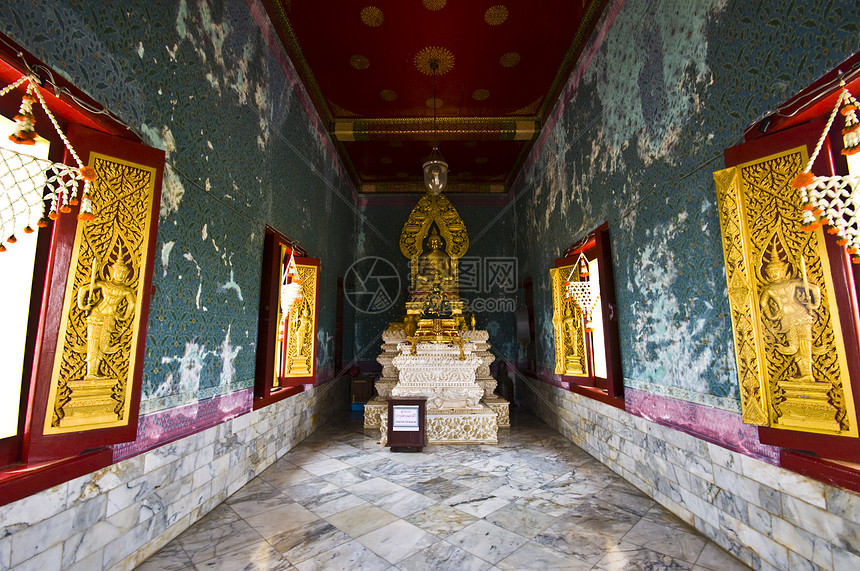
372;331;510;445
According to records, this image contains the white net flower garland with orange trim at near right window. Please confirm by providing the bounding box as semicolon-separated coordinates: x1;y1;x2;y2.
791;81;860;264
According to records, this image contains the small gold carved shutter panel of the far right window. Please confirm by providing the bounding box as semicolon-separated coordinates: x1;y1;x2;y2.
549;264;590;377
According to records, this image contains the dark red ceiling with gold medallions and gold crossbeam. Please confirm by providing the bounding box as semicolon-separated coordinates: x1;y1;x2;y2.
267;0;604;192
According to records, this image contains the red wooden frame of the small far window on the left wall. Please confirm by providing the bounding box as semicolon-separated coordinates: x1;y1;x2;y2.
253;226;320;410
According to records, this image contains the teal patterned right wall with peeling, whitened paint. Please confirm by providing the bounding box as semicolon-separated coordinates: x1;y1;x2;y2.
515;0;860;412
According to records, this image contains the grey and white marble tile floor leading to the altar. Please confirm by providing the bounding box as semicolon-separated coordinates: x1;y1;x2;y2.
138;409;747;571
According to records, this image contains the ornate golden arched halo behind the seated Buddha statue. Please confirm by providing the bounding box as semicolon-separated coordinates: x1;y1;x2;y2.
400;193;469;260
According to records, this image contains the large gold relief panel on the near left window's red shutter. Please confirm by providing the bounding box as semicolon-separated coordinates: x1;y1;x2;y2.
44;153;156;434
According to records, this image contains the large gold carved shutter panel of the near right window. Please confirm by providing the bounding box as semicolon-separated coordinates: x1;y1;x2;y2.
714;147;858;437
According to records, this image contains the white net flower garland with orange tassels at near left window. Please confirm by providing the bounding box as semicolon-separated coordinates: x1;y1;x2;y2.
0;75;97;252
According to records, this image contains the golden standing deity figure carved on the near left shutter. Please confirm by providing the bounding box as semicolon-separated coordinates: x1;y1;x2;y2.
77;255;137;379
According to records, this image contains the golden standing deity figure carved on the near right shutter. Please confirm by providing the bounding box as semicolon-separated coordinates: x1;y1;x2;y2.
759;244;821;382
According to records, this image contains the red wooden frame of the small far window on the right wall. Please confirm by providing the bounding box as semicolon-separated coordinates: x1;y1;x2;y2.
555;222;624;409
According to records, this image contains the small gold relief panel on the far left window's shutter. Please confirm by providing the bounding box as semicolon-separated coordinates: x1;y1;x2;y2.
282;264;318;380
